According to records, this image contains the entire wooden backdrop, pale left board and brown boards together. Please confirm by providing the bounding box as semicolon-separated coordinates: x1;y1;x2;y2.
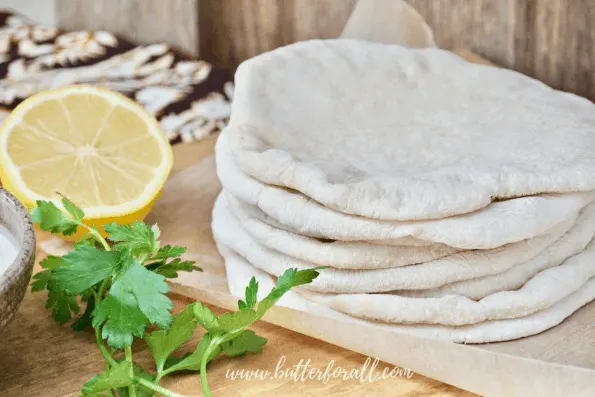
51;0;595;100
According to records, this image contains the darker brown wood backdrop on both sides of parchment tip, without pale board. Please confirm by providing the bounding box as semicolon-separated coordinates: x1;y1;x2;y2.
199;0;595;100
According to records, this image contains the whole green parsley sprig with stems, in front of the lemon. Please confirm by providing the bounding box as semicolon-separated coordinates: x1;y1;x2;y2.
31;197;319;397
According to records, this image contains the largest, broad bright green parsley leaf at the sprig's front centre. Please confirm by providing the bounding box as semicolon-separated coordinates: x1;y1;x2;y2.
93;258;173;348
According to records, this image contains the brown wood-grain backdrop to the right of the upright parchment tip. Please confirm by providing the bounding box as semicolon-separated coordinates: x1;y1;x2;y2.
407;0;595;100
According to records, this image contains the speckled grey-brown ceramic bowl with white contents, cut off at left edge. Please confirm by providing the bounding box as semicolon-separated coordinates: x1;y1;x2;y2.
0;187;35;331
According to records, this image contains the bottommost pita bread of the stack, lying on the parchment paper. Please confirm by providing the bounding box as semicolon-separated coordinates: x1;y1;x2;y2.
217;243;595;344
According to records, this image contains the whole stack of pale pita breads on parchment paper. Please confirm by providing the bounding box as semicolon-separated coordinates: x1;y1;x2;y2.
212;39;595;343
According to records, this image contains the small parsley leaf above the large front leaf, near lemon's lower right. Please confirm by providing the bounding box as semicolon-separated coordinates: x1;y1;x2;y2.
104;221;160;257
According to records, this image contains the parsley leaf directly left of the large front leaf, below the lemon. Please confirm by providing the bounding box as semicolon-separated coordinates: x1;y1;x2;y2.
49;246;120;295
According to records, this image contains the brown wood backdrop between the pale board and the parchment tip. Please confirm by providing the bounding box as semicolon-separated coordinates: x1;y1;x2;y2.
199;0;355;67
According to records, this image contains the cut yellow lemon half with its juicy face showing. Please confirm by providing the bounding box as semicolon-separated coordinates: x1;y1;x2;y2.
0;85;173;237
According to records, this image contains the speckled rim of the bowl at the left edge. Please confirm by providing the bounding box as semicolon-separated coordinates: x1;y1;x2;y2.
0;186;35;295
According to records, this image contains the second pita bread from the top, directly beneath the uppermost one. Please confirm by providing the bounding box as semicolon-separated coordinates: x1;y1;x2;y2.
216;130;595;249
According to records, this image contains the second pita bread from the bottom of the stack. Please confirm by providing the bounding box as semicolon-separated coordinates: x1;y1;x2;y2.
301;230;595;325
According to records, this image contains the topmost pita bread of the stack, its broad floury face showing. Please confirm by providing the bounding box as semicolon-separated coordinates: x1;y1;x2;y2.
229;39;595;220
